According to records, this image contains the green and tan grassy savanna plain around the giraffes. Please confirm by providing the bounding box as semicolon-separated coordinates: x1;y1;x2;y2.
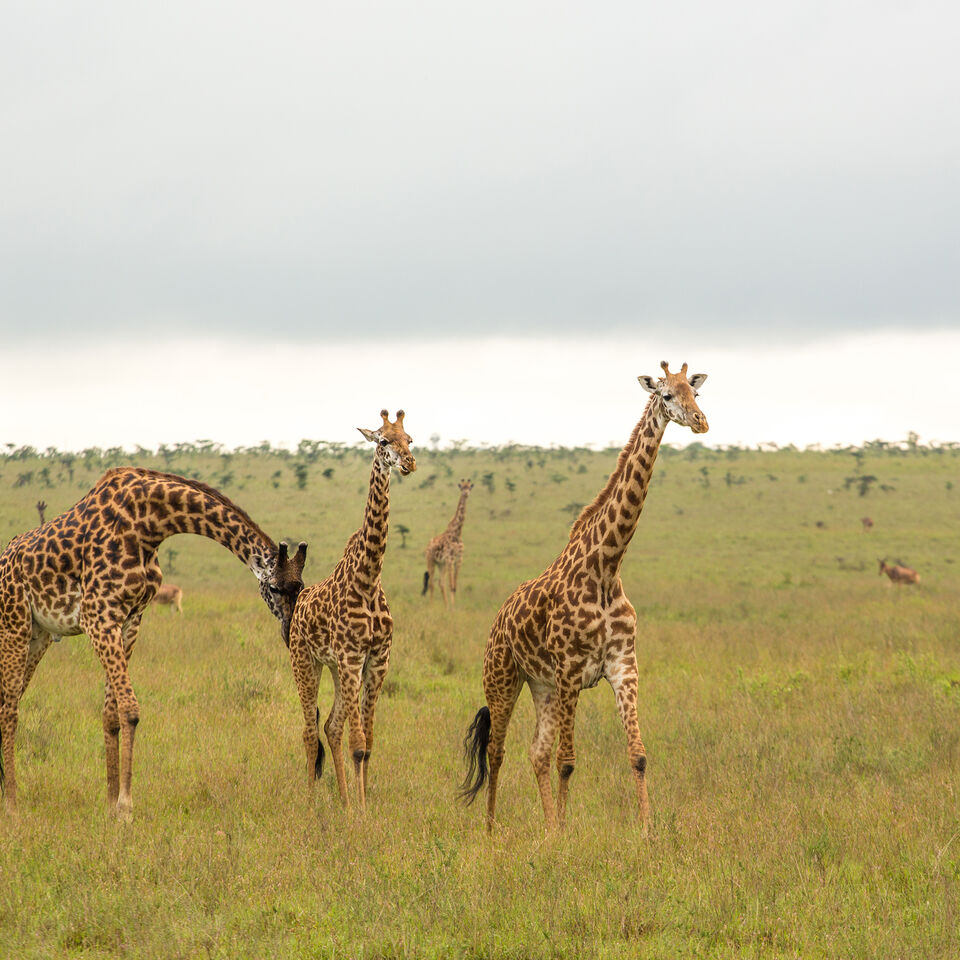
0;438;960;958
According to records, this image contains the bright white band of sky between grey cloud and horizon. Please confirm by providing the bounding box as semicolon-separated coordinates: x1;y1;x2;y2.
0;330;960;450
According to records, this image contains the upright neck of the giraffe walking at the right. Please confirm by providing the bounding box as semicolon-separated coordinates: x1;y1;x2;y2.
570;397;667;583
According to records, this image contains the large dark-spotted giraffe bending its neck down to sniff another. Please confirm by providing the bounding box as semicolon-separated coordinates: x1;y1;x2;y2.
0;467;307;820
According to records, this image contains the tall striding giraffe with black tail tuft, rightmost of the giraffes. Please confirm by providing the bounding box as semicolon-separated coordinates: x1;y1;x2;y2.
461;361;708;832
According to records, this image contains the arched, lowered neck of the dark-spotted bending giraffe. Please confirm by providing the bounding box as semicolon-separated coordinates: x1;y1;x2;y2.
124;471;277;580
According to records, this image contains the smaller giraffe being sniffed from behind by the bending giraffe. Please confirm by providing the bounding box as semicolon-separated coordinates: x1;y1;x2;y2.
290;410;417;809
